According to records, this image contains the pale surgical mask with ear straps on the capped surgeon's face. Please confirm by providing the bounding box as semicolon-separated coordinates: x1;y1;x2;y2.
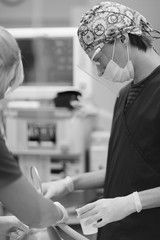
102;42;134;83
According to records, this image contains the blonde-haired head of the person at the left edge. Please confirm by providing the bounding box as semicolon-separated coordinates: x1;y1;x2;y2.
0;27;24;99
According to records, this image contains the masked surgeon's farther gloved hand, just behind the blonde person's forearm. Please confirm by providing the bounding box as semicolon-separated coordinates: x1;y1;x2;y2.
42;177;74;199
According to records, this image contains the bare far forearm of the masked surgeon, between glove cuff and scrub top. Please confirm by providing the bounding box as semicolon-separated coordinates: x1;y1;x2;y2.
72;170;105;190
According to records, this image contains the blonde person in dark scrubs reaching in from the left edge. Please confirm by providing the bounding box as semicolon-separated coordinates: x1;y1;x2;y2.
0;27;68;240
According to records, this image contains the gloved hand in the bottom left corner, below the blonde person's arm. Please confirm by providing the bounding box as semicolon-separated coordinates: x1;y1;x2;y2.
0;216;29;239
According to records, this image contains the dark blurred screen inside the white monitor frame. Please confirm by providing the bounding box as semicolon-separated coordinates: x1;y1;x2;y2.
17;37;73;86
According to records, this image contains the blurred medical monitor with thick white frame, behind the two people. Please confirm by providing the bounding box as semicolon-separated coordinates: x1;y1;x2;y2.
8;27;91;99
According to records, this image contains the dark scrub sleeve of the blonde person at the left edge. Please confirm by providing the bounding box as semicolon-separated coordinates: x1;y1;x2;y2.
0;134;22;188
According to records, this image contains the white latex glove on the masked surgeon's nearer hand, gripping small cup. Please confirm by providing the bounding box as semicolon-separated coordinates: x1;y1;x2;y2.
77;194;136;228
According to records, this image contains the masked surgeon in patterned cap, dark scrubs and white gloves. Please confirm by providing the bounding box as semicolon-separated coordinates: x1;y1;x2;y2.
43;2;160;240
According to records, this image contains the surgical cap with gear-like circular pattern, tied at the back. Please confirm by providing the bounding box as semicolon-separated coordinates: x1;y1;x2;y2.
78;2;154;53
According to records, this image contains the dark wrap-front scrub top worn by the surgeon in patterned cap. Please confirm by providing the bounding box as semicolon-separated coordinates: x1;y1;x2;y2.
98;66;160;240
